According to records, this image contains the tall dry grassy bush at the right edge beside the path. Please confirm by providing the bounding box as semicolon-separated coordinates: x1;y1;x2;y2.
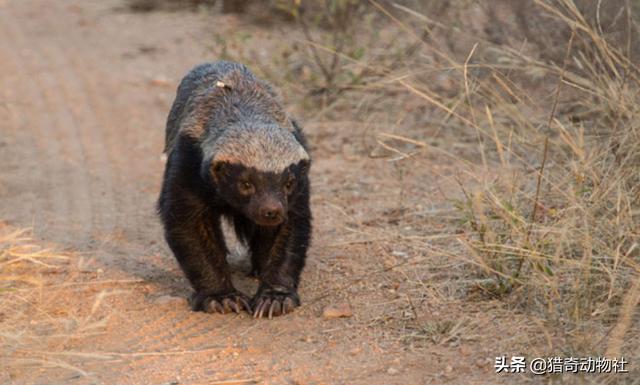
370;0;640;354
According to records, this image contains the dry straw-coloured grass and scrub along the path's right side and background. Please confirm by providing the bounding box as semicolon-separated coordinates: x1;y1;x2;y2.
208;0;640;360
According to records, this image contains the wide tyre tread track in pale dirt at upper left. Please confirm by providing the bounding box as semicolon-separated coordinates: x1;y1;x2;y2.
3;3;155;249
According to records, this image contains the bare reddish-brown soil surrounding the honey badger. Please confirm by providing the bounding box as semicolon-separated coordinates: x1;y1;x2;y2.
0;0;521;385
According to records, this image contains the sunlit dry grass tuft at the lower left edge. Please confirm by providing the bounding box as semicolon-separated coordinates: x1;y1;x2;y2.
0;225;122;381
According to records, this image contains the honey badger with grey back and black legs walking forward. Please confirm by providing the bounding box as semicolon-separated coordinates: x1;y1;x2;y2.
158;61;311;318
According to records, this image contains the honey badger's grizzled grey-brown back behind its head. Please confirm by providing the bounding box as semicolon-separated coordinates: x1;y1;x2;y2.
164;61;295;154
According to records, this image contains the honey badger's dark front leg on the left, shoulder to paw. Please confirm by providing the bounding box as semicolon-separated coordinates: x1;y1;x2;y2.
158;139;251;313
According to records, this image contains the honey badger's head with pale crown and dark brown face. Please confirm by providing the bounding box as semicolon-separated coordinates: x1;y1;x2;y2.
201;124;310;226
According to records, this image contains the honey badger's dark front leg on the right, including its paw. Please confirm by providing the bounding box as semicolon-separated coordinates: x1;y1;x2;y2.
250;200;311;318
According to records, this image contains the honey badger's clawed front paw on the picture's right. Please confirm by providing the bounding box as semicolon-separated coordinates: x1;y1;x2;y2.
251;286;300;319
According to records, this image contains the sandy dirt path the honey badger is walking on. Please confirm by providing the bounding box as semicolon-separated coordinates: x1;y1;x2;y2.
0;0;500;385
